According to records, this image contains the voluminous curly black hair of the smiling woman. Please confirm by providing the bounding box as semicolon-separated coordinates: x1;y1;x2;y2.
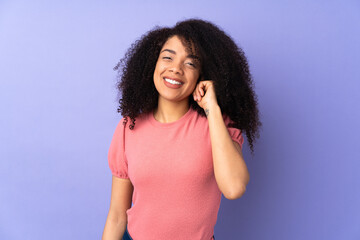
114;19;262;154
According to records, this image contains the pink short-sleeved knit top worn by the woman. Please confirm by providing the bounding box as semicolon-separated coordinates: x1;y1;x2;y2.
108;108;244;240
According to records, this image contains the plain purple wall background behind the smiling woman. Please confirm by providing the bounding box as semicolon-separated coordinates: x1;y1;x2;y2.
0;0;360;240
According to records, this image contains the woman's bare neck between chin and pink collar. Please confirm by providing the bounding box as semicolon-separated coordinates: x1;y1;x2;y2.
154;99;190;123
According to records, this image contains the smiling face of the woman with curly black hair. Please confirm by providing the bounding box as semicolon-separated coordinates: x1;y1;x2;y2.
154;36;200;105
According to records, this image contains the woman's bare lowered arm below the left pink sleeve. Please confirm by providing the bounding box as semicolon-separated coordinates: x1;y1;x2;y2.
102;176;134;240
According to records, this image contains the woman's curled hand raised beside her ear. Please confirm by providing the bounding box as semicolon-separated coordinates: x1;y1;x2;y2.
193;80;218;110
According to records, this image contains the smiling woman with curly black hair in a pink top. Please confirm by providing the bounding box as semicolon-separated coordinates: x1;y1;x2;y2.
103;19;261;240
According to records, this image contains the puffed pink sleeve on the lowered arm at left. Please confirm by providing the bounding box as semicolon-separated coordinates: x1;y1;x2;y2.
108;118;129;179
